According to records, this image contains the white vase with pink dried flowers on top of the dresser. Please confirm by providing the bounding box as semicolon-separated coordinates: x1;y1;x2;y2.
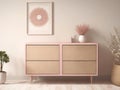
75;24;89;43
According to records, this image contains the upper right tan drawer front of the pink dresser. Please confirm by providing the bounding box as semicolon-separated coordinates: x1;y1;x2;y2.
63;45;97;60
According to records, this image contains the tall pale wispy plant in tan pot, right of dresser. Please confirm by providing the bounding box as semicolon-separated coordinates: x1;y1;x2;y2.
109;28;120;85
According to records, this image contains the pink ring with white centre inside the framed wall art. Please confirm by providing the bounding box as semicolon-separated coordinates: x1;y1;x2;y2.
30;8;48;27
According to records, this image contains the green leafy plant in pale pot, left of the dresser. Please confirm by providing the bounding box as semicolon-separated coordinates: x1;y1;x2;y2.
0;51;9;84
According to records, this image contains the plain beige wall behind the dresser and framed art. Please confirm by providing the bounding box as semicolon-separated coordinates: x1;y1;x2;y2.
0;0;120;79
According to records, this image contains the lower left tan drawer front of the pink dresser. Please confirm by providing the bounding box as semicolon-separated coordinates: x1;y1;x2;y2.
26;61;60;74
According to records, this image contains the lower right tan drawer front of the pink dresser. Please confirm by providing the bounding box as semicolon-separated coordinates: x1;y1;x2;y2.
63;61;97;75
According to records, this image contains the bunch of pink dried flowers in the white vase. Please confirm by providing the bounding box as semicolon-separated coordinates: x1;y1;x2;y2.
76;24;89;35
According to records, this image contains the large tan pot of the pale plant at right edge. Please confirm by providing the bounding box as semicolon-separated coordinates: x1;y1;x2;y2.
111;64;120;86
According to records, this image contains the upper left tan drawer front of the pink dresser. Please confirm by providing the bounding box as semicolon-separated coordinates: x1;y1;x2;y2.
26;45;59;60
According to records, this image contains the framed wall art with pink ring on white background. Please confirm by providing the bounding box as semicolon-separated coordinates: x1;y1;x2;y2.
27;2;53;35
